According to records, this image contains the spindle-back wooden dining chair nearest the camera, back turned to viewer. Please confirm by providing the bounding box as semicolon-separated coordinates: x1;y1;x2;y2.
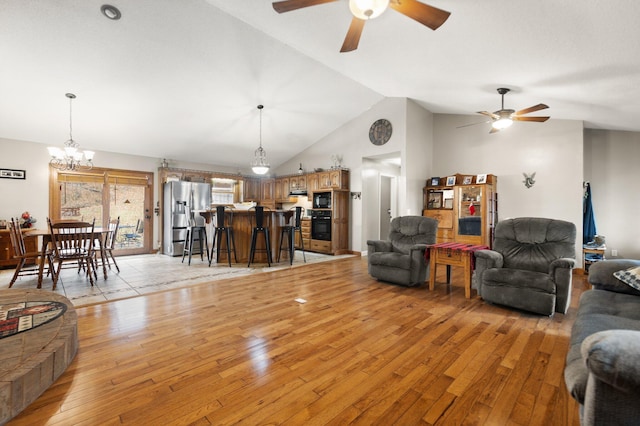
47;219;95;290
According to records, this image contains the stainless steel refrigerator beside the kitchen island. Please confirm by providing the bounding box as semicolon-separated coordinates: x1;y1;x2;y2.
162;181;211;256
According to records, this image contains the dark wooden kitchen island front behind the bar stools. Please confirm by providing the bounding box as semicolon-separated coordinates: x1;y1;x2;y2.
200;209;293;266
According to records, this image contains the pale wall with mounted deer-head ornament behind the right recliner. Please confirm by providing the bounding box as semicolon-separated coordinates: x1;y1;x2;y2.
433;114;583;263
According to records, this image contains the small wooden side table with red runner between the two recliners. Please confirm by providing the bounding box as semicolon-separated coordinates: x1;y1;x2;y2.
428;242;489;299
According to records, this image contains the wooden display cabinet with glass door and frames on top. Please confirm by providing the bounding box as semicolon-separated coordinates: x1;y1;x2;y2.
423;174;498;247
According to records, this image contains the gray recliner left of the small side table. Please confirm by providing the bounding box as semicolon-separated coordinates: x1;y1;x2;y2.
367;216;438;286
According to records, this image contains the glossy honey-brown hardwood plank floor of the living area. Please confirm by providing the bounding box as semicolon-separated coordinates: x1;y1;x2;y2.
9;257;585;425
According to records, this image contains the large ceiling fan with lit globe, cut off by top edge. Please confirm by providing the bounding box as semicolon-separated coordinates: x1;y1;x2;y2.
273;0;451;52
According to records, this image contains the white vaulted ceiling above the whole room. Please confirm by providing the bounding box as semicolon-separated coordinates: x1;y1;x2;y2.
0;0;640;169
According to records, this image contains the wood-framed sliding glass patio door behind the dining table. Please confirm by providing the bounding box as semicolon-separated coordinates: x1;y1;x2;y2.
49;168;153;254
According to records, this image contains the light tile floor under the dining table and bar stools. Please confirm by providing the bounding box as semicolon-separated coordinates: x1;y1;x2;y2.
0;252;352;307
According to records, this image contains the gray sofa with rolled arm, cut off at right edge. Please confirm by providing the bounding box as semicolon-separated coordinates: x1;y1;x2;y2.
564;259;640;425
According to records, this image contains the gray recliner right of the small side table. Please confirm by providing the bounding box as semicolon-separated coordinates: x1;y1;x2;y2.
474;217;576;316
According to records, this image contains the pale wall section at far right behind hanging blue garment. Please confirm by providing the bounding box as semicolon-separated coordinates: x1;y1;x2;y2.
584;129;640;259
